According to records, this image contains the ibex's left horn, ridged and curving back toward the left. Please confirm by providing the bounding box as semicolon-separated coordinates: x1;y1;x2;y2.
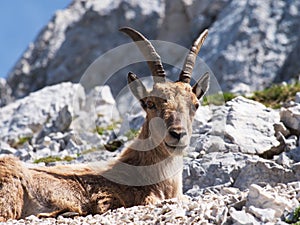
120;27;166;82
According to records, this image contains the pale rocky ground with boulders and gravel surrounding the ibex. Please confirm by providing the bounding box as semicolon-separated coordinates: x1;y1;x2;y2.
0;83;300;224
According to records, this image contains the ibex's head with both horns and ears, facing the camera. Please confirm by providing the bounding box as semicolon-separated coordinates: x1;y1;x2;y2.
120;27;209;154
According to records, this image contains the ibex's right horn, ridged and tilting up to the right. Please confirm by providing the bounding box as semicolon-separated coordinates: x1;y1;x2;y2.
179;29;208;83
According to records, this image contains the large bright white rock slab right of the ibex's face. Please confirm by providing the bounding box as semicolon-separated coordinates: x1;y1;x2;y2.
225;97;280;154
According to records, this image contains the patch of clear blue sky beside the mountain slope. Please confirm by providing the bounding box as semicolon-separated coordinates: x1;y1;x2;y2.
0;0;71;77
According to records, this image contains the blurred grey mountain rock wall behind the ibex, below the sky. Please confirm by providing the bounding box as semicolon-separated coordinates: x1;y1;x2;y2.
8;0;300;97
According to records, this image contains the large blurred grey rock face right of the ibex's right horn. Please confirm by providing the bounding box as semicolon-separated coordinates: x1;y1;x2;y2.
201;0;300;92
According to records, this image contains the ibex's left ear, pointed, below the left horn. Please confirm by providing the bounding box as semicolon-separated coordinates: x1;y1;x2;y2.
127;72;148;109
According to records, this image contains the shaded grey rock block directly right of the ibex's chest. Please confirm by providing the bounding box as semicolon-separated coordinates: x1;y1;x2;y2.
183;152;253;192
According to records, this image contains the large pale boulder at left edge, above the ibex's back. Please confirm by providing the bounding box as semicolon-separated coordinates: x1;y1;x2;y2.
0;83;85;142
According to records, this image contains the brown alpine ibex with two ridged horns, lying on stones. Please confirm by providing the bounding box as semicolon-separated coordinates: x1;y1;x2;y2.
0;28;209;221
